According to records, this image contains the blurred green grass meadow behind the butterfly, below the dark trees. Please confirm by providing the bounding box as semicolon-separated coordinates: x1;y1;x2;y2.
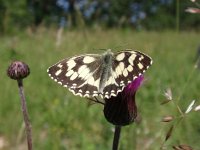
0;29;200;150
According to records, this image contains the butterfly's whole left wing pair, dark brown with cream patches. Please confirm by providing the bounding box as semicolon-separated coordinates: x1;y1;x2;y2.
47;54;101;97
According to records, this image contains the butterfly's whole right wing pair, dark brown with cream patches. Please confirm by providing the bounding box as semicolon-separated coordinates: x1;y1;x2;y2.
103;50;152;99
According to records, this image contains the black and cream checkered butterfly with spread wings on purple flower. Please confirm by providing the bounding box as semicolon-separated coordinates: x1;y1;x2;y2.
47;49;153;99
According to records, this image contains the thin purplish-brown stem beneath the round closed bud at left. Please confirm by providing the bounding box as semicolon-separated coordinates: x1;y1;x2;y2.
17;80;32;150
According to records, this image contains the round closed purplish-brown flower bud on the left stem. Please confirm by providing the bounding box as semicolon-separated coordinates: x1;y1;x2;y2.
7;61;30;80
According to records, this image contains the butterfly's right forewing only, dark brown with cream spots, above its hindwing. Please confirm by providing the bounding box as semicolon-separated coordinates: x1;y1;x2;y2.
113;50;152;82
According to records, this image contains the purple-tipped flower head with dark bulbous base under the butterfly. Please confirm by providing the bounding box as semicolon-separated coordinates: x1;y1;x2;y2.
104;75;144;126
